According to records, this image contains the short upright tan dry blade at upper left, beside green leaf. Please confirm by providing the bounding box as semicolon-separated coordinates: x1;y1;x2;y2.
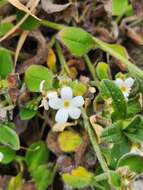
14;31;29;70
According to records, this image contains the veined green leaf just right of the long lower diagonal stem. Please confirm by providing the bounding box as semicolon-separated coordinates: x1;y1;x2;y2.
101;122;122;142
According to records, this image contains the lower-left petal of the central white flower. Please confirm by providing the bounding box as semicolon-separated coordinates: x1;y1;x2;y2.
55;108;68;123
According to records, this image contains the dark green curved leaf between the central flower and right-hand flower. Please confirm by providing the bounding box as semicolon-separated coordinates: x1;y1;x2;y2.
100;79;127;118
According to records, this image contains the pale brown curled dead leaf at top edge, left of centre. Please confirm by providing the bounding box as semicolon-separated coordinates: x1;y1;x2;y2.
41;0;72;14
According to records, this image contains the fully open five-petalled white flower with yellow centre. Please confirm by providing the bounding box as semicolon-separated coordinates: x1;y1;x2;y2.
49;87;84;123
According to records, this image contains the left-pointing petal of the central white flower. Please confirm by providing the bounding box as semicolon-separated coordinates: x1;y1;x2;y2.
49;97;63;110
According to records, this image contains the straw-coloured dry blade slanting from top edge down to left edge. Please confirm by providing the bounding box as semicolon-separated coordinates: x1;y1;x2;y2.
0;0;40;42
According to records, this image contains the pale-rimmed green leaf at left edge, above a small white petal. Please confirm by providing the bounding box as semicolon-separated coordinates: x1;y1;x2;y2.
0;124;20;150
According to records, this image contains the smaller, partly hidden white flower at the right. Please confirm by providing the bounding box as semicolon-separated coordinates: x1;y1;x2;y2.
115;77;134;100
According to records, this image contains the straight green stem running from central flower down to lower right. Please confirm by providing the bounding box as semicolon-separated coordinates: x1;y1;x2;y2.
82;109;109;173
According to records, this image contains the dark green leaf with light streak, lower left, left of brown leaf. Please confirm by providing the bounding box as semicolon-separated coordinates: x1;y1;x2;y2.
25;141;49;171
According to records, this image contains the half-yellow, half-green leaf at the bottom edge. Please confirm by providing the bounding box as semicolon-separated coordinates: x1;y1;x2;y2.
62;167;93;188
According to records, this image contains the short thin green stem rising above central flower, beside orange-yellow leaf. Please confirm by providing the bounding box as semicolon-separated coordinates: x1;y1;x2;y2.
56;42;70;75
